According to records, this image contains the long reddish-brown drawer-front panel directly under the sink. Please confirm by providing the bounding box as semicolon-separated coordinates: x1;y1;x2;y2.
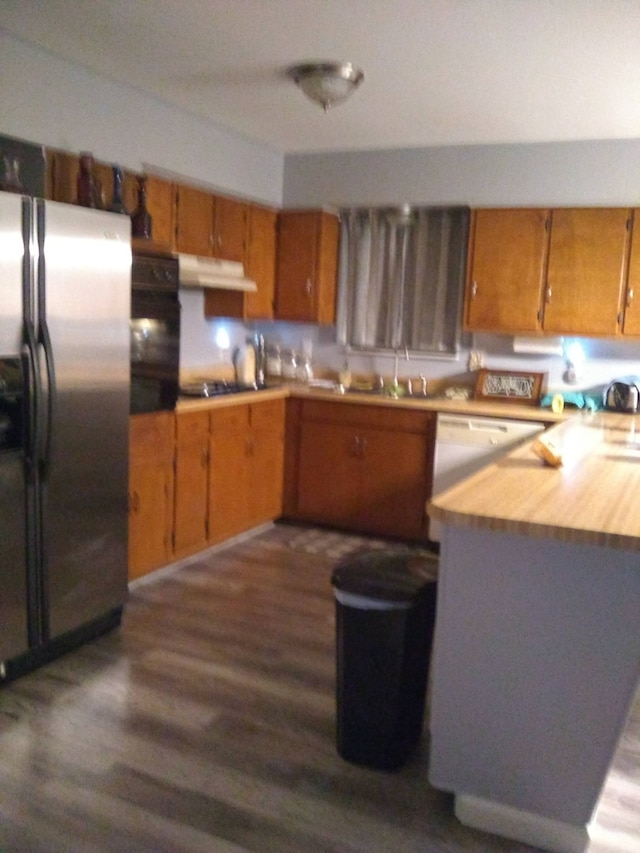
302;400;434;433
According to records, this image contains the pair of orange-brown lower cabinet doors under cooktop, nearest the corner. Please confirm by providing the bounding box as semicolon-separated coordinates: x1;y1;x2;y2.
209;400;285;544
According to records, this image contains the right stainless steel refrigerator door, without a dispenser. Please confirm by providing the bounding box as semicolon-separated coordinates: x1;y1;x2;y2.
38;202;131;639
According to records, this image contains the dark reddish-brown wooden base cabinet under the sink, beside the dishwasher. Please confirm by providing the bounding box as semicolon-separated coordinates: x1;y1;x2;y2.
289;401;435;539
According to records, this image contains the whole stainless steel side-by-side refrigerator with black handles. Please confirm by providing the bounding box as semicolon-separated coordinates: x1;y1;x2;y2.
0;188;131;681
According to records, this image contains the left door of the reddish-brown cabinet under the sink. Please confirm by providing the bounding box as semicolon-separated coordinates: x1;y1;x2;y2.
298;421;361;528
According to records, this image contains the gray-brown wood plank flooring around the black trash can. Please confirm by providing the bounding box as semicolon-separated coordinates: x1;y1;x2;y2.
0;525;640;853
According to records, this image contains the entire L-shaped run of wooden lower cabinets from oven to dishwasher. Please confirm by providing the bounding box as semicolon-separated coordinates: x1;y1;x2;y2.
129;399;435;579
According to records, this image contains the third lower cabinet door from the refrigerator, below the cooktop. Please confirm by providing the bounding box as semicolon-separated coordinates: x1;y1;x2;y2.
209;404;251;543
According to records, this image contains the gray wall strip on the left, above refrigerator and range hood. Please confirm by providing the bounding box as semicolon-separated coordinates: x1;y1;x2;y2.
0;30;284;205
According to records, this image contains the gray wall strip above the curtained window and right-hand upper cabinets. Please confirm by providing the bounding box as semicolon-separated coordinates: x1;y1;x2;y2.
283;139;640;207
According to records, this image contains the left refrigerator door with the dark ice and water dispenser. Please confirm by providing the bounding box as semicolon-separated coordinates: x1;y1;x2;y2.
0;193;28;661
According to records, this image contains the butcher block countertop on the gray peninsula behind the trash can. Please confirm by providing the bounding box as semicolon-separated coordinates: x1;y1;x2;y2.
428;412;640;551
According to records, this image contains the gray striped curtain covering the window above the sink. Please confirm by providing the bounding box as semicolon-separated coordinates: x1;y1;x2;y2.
337;207;469;353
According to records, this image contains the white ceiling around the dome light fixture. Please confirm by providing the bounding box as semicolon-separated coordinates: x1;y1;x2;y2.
0;0;640;152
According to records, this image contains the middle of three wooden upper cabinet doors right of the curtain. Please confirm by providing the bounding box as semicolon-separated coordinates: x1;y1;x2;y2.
544;208;631;335
